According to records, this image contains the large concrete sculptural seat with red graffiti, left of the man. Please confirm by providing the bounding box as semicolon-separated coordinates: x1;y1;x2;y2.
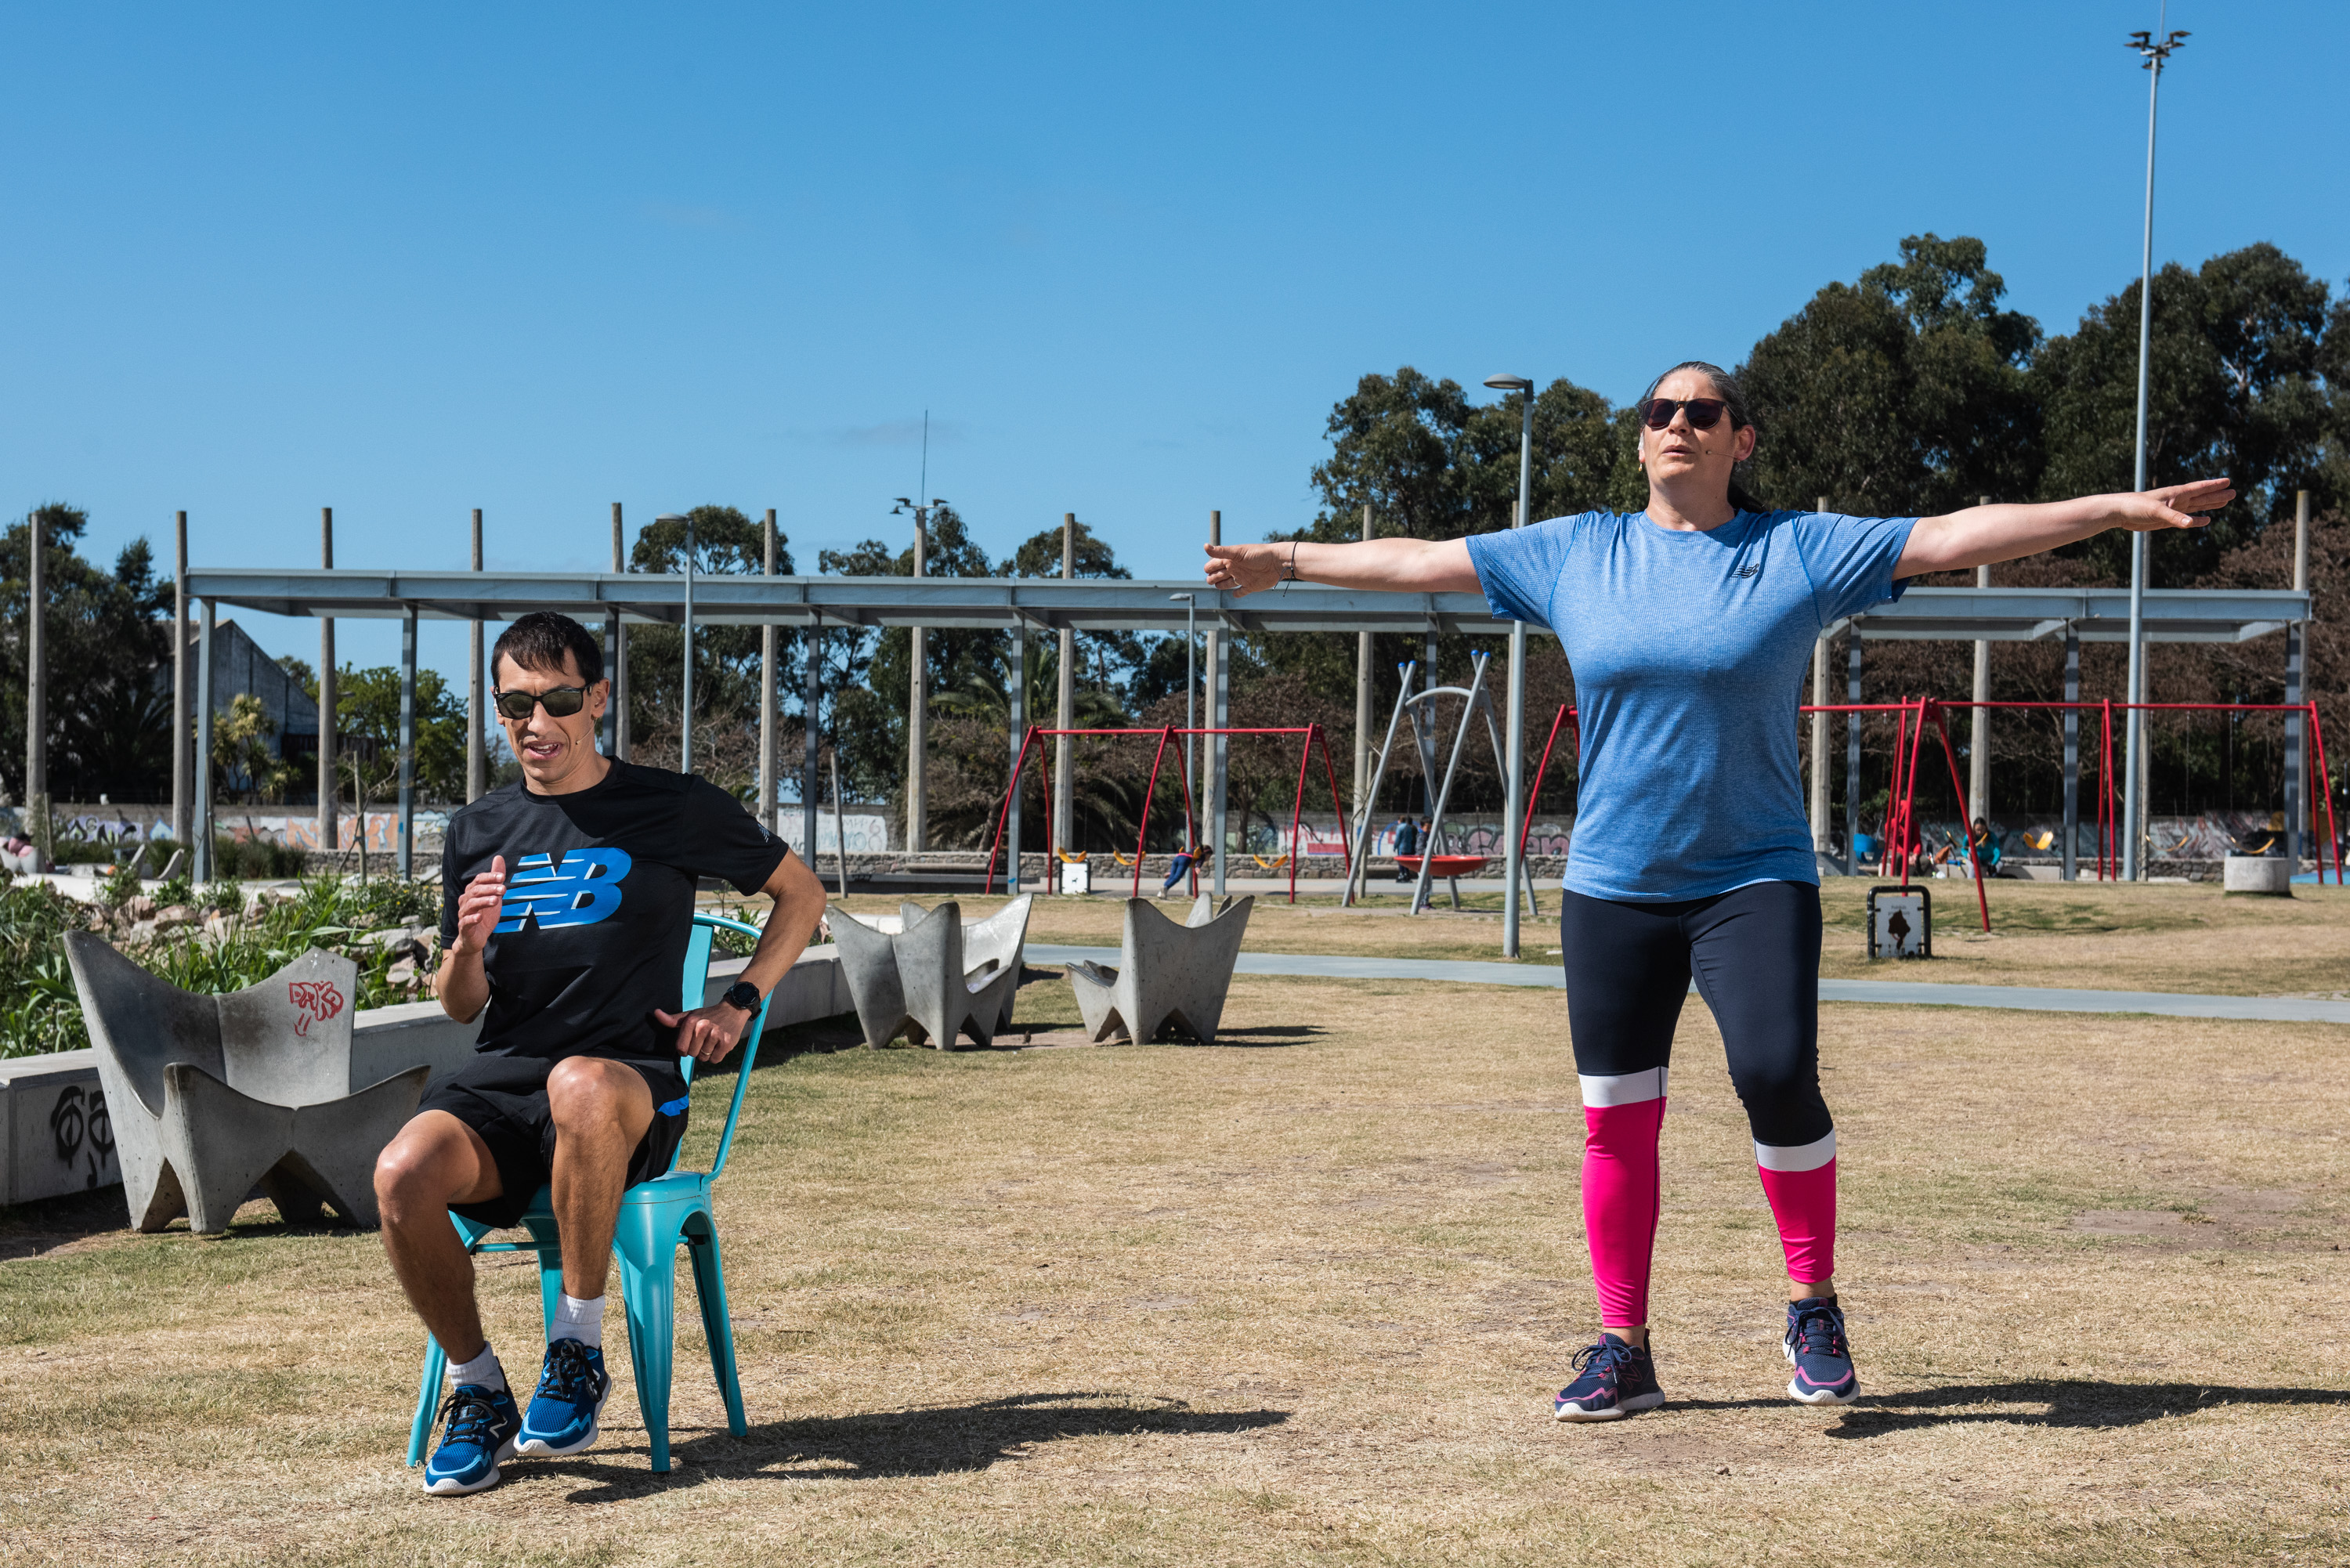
66;931;432;1234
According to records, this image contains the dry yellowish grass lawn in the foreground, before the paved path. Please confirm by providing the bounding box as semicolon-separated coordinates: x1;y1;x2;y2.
0;963;2350;1568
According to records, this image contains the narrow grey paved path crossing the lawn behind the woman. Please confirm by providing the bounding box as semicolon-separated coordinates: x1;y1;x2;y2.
1027;943;2350;1023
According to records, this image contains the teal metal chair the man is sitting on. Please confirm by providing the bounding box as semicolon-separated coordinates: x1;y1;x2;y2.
409;915;766;1472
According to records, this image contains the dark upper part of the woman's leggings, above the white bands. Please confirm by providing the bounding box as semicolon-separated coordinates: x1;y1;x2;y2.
1558;882;1835;1147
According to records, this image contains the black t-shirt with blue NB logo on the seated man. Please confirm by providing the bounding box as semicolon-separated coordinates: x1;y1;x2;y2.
442;761;792;1058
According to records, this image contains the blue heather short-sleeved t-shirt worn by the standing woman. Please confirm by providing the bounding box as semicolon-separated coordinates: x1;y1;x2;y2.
1469;512;1918;901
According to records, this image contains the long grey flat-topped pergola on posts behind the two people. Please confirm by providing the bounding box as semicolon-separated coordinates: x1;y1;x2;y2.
181;566;2310;945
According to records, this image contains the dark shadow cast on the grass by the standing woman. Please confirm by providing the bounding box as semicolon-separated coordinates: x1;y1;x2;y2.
1676;1378;2350;1439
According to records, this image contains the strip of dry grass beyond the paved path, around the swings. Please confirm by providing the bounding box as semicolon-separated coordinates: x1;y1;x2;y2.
848;880;2350;997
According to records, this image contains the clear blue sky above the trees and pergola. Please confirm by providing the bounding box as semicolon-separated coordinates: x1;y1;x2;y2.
0;0;2350;686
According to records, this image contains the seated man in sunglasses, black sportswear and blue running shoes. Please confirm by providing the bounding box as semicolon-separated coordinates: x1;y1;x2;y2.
376;611;825;1495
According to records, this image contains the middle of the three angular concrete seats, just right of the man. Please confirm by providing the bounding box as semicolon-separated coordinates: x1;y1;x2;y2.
832;894;1036;1051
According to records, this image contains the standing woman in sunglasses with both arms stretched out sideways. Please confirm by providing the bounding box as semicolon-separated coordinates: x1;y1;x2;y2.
1208;359;2235;1420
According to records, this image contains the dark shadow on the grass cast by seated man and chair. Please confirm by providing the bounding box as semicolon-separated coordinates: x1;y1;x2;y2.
548;1394;1290;1502
